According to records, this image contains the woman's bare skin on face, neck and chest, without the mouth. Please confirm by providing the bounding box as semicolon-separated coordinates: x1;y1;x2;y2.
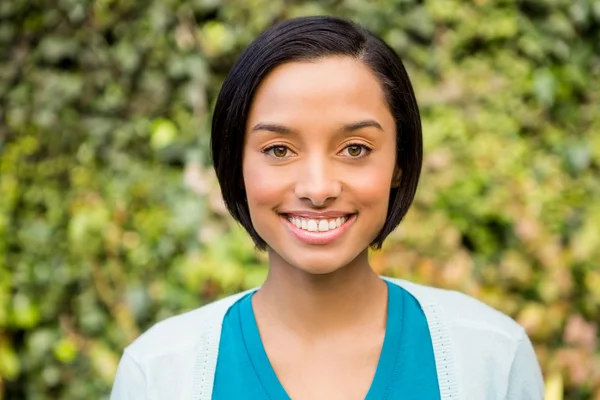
243;57;398;400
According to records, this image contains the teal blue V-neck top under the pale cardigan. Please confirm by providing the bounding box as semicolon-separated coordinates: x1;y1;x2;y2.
213;282;440;400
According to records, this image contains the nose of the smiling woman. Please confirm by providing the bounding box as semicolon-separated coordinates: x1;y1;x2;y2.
294;159;342;207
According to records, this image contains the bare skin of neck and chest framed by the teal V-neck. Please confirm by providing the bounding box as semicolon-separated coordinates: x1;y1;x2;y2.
253;255;387;400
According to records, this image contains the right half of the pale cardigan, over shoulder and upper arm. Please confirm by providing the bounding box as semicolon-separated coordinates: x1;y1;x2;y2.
386;278;544;400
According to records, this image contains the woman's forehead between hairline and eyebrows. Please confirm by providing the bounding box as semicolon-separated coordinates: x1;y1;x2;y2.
249;57;389;122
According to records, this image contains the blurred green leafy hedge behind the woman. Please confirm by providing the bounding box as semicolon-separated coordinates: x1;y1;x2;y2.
0;0;600;400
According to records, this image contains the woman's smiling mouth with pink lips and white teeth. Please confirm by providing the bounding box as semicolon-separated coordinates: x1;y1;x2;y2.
281;214;356;245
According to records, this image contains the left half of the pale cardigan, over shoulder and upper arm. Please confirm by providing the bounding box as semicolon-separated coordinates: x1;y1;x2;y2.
111;292;247;400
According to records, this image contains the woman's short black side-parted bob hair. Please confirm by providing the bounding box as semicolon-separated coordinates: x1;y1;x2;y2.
211;16;423;249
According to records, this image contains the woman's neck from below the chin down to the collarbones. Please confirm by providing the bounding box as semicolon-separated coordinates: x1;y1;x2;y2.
253;250;387;337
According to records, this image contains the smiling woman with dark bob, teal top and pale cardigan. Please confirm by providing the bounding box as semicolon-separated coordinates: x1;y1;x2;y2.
112;17;543;400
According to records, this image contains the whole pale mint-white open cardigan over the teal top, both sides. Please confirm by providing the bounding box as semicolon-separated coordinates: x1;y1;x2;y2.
111;278;544;400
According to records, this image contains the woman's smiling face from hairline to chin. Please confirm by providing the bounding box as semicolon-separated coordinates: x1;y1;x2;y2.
243;57;396;274
